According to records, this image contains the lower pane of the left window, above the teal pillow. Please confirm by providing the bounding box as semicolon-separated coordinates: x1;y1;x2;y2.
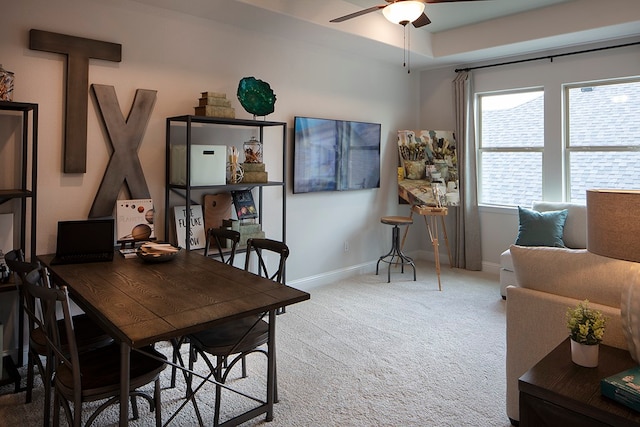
480;152;542;206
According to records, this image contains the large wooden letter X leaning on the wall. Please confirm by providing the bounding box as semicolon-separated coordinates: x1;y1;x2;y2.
89;84;156;218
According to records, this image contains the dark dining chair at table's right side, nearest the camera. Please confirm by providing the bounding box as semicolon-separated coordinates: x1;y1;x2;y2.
188;239;289;426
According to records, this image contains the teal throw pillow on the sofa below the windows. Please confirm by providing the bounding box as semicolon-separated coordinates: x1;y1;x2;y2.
516;206;568;248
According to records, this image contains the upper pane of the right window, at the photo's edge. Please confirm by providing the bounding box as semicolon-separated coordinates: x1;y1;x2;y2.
569;82;640;147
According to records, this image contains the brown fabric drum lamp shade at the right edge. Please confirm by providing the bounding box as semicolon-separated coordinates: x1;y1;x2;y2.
587;190;640;262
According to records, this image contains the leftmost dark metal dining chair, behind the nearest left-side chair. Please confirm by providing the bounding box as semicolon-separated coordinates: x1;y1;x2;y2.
5;249;113;426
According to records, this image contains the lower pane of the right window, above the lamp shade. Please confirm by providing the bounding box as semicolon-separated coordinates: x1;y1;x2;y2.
569;151;640;203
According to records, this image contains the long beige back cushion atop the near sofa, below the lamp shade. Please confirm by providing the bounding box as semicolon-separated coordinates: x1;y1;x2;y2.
510;245;640;307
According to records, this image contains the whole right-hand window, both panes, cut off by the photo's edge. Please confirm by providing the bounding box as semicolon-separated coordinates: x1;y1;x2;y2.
564;81;640;203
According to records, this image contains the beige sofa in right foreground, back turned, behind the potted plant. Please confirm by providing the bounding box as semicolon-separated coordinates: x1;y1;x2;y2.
506;245;640;423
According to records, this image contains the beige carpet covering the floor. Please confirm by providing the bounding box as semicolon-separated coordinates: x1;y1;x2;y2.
0;261;509;427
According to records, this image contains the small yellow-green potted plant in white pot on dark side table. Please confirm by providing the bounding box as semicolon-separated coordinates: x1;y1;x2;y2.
567;300;607;368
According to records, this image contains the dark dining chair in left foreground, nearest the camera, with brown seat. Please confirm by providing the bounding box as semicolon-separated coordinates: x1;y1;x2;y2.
23;268;166;427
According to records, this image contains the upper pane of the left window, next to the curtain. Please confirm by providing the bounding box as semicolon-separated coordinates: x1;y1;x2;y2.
480;90;544;148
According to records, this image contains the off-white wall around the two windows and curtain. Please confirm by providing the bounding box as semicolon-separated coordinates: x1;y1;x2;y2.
420;40;640;272
